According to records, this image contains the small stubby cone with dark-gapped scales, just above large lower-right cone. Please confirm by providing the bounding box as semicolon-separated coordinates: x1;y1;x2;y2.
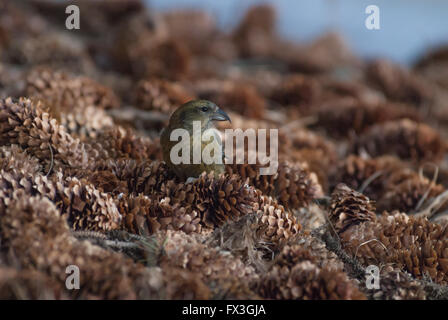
329;183;376;233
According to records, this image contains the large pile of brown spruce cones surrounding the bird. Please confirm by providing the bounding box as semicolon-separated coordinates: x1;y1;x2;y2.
0;0;448;299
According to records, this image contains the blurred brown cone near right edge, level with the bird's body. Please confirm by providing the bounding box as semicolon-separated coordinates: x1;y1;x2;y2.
351;119;445;163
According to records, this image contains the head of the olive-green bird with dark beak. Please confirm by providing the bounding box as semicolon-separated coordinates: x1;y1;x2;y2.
169;100;231;130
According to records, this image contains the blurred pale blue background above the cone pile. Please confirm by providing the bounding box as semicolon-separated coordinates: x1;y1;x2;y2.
147;0;448;65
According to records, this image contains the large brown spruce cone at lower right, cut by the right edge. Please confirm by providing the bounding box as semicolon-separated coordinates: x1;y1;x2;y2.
339;212;448;284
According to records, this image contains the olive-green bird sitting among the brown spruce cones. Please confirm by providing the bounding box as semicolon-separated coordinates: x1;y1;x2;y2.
160;100;230;181
